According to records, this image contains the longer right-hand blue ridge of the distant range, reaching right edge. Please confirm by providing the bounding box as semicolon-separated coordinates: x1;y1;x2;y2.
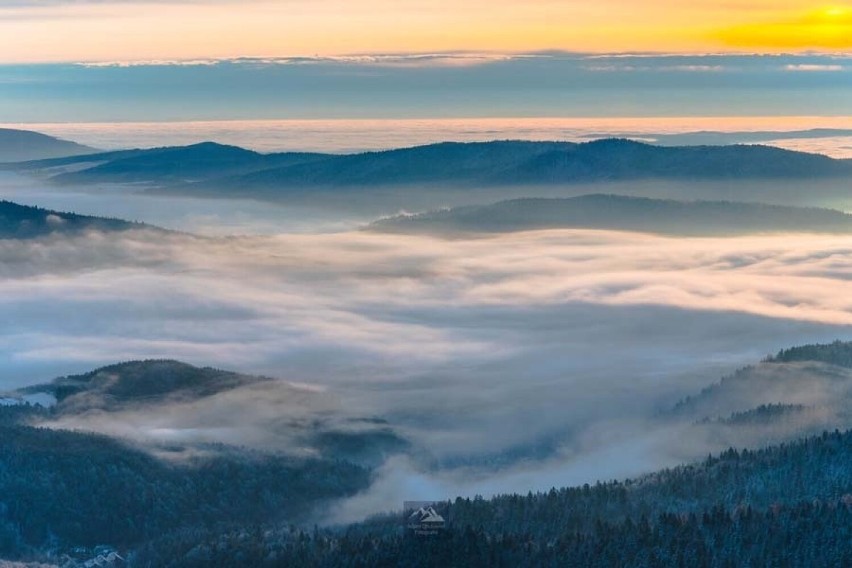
200;139;852;195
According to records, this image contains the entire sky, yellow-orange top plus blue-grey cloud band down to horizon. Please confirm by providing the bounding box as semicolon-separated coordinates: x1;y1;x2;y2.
0;0;852;123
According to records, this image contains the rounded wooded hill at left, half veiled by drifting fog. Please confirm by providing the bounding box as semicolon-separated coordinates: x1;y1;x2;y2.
16;359;409;466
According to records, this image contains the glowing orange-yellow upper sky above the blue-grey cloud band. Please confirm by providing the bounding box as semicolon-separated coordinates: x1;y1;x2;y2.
0;0;852;63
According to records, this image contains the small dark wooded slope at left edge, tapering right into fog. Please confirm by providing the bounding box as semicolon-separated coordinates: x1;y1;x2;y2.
0;201;151;239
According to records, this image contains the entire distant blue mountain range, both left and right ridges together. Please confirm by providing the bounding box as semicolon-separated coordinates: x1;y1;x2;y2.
8;139;852;198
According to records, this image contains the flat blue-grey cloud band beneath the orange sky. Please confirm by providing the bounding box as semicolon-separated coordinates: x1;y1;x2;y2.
0;52;852;123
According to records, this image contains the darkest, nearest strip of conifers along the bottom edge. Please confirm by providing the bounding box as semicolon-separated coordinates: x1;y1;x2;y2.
132;500;852;568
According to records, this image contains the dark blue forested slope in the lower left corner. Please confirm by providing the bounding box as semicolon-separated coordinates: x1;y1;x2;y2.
0;407;369;558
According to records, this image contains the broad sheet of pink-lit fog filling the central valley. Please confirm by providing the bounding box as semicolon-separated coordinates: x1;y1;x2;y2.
0;174;852;521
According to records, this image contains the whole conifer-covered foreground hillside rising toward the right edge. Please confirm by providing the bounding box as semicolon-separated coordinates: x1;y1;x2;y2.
133;432;852;568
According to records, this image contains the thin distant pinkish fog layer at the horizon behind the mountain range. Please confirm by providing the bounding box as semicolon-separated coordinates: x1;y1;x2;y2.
10;117;852;158
